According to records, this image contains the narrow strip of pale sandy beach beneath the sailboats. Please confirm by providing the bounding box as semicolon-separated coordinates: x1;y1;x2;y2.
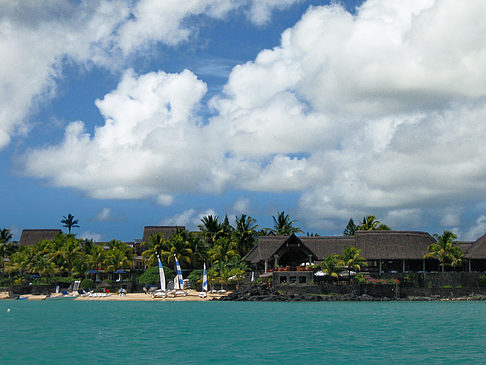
0;289;231;302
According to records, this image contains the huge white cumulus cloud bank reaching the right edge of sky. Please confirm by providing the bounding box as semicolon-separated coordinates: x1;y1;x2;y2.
21;0;486;233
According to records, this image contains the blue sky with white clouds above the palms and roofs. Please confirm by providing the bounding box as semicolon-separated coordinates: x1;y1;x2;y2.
0;0;486;241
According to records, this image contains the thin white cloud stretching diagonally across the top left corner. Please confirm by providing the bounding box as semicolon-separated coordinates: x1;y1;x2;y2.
0;0;297;149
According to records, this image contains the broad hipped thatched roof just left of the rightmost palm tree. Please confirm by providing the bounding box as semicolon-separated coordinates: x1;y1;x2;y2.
354;230;435;260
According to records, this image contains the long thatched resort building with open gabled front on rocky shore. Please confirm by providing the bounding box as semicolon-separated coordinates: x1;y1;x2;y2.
243;230;486;282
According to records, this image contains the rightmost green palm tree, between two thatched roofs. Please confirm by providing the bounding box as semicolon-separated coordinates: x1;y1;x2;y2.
425;231;464;272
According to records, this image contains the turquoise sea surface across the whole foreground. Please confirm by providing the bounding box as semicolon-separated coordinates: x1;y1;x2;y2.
0;300;486;364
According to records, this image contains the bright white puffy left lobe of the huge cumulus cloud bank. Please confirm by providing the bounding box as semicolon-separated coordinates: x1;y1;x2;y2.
25;71;212;199
